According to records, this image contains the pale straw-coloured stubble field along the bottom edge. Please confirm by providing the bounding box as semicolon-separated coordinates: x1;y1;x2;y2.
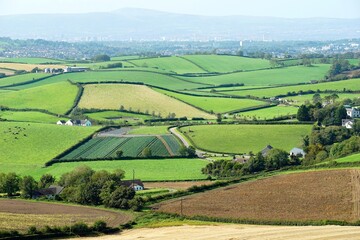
72;224;360;240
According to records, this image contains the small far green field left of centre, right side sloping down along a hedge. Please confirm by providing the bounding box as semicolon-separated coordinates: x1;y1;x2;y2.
130;57;205;74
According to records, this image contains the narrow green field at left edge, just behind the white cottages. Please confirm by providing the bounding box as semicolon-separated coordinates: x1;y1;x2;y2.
0;111;63;124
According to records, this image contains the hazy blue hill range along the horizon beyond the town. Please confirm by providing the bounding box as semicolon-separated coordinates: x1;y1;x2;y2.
0;8;360;41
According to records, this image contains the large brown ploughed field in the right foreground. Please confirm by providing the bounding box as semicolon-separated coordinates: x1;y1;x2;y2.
155;170;360;221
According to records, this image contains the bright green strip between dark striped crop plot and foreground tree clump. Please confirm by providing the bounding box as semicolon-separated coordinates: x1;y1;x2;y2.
29;158;208;181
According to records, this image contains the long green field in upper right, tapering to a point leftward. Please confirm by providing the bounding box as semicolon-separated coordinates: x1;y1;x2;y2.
182;64;330;85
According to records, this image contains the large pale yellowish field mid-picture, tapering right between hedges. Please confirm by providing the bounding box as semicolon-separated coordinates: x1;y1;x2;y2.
79;84;214;118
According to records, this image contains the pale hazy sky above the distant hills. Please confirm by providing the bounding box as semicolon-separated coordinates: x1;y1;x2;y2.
0;0;360;18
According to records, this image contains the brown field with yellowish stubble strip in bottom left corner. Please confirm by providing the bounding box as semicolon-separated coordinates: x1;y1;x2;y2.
0;199;132;231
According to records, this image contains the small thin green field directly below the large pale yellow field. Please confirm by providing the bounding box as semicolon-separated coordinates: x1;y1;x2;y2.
86;111;153;123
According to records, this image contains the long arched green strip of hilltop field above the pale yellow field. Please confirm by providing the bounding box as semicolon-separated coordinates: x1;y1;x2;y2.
13;70;206;90
